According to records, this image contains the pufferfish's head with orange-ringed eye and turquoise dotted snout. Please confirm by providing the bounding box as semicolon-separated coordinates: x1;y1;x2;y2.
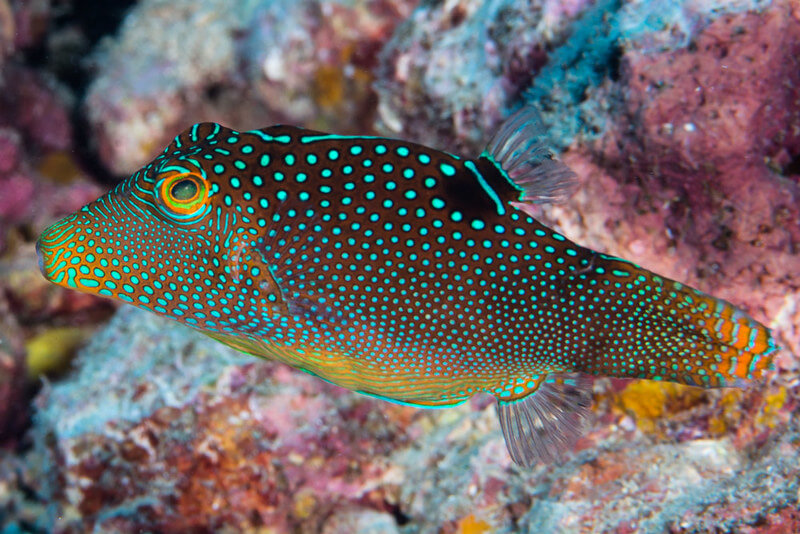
36;123;270;327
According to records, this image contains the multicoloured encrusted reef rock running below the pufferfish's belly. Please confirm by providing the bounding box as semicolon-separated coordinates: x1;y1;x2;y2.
7;308;800;532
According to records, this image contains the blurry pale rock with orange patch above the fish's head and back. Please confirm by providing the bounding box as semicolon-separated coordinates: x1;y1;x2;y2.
86;0;412;174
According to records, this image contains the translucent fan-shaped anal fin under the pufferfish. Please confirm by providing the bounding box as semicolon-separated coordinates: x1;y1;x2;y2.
497;374;591;467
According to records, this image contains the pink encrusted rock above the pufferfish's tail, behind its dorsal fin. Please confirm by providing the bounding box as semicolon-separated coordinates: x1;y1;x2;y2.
588;6;800;356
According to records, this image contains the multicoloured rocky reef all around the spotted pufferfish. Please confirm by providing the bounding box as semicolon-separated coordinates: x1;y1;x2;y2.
0;0;800;534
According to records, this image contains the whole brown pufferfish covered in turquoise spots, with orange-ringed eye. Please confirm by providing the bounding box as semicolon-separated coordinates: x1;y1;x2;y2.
37;107;776;466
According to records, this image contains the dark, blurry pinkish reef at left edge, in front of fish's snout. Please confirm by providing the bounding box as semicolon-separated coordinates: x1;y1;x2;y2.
0;1;113;454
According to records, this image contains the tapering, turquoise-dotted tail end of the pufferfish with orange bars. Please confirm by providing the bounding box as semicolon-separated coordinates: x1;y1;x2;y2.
567;253;778;387
